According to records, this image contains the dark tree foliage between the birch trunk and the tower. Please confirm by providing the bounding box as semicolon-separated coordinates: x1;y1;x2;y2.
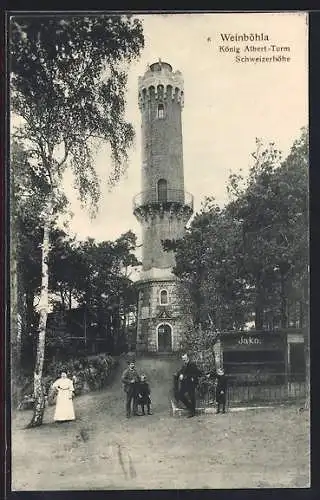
49;231;139;315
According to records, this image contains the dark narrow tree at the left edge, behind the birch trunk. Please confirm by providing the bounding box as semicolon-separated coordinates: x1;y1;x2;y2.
10;141;47;402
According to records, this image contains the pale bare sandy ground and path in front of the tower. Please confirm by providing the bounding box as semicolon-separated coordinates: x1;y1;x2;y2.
12;359;310;490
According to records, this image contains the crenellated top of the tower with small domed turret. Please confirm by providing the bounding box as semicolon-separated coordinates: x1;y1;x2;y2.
138;59;184;109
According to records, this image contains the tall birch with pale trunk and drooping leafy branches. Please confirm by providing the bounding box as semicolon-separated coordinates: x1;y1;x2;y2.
10;16;143;426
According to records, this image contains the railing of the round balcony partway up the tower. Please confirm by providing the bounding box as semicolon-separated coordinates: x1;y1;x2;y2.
133;189;193;210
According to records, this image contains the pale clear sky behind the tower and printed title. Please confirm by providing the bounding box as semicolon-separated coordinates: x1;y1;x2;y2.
60;13;308;250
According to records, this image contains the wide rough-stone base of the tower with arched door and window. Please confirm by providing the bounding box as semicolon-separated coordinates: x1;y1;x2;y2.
136;276;189;353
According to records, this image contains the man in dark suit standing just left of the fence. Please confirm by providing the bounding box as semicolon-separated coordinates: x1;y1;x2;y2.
176;354;202;418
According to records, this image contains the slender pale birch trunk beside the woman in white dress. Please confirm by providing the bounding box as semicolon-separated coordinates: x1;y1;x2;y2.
27;210;51;428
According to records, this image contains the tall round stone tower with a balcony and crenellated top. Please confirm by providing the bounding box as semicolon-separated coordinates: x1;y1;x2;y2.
133;60;193;352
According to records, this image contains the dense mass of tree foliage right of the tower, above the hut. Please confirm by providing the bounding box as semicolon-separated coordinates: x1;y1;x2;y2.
169;129;308;331
